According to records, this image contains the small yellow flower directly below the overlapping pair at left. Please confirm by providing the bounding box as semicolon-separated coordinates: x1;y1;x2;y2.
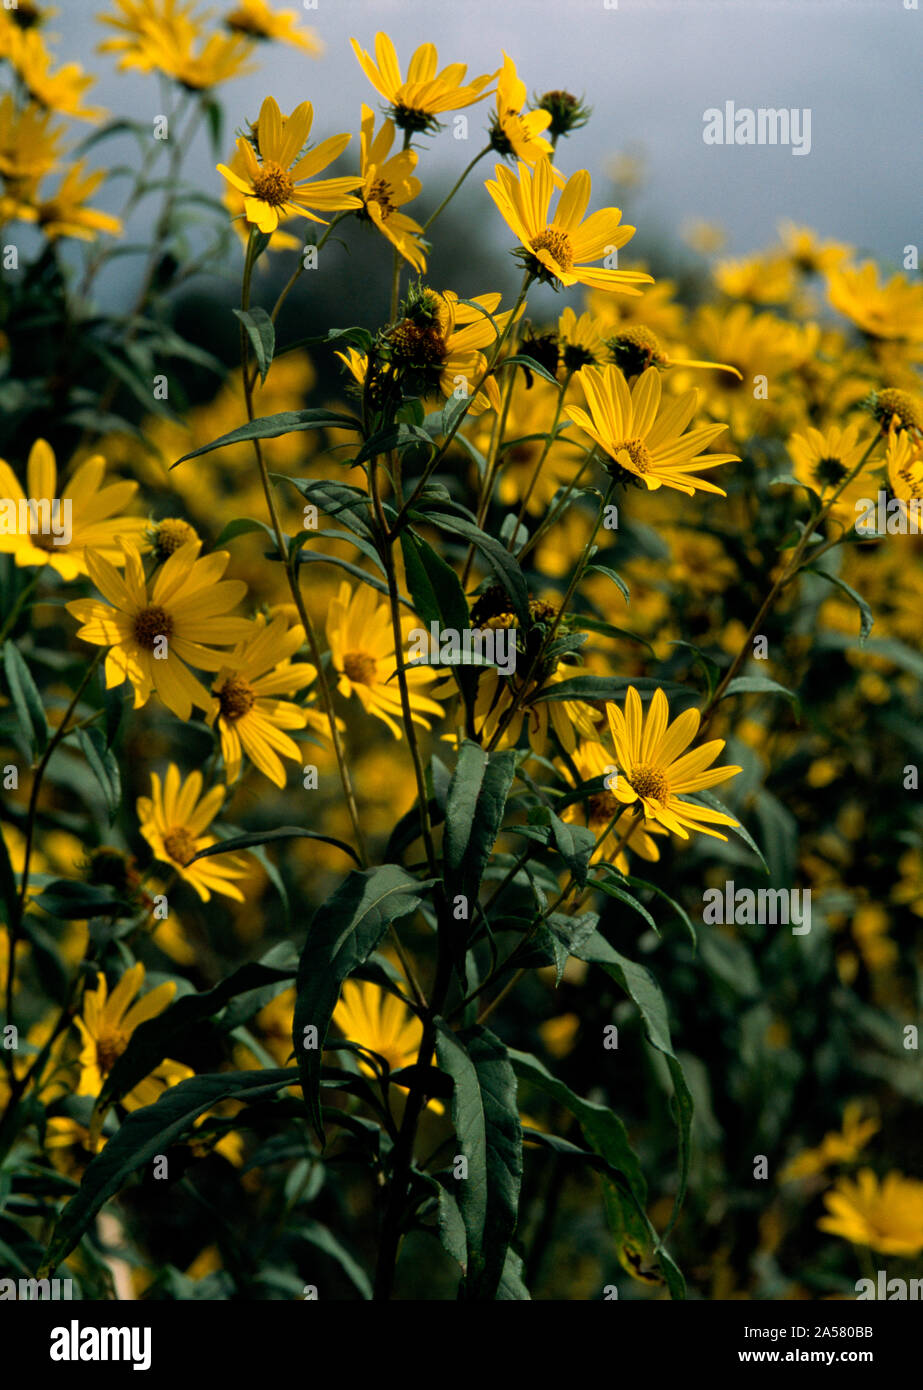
136;763;247;902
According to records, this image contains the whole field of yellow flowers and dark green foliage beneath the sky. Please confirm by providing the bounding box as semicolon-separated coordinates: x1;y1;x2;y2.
0;0;923;1301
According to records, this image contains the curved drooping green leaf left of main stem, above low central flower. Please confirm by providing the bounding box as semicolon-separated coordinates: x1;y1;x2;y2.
292;865;435;1144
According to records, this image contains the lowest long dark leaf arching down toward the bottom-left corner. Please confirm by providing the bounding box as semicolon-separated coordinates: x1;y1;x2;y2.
39;1068;295;1277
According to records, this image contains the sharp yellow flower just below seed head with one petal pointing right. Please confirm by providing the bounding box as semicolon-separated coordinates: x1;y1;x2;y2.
564;366;740;498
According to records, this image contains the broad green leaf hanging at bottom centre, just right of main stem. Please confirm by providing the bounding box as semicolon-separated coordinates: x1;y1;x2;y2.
436;1019;523;1301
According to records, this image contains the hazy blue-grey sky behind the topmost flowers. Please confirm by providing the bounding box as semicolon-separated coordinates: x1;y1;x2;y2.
53;0;923;293
